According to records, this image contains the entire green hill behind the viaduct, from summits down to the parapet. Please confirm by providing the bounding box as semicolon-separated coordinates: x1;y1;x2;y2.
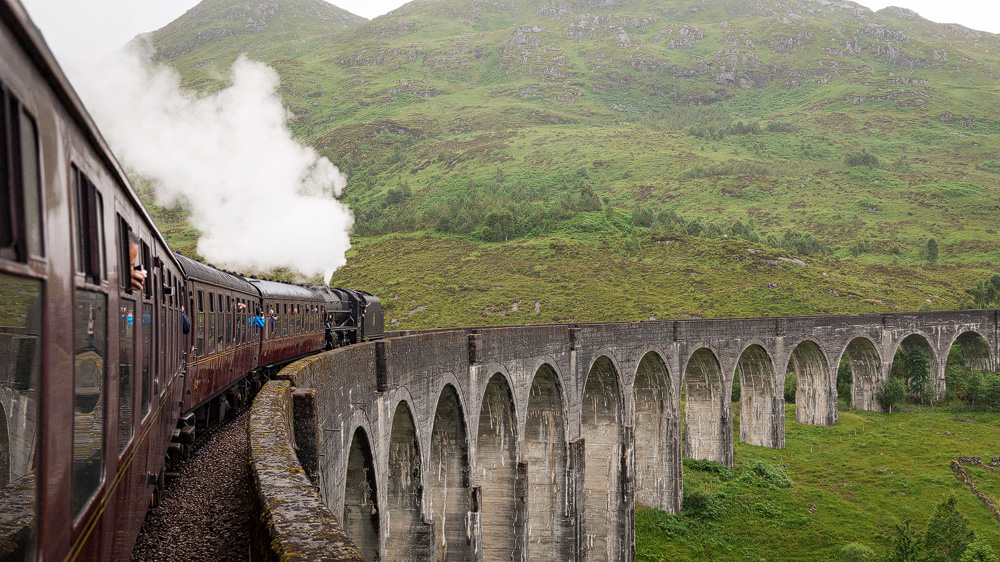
139;0;1000;327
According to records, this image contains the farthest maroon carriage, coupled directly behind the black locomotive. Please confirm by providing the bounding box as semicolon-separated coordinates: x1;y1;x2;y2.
247;278;326;365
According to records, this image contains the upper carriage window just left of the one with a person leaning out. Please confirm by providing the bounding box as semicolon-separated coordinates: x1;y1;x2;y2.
72;165;105;285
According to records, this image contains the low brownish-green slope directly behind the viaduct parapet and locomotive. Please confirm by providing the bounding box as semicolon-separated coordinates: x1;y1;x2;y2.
333;232;978;329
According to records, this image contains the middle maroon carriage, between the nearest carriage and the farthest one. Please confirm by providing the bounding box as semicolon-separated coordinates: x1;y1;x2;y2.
177;254;260;428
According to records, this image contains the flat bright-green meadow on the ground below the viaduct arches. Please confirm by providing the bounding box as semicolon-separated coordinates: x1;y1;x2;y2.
636;405;1000;562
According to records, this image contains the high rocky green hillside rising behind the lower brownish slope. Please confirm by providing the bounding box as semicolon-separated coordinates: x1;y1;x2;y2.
145;0;1000;263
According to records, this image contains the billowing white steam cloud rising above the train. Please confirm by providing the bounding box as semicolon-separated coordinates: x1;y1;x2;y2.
75;44;354;281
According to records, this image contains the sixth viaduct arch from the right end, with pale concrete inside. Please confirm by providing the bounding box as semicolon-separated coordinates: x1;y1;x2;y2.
683;347;733;466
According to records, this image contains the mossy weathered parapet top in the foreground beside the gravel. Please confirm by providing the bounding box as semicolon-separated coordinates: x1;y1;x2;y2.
249;381;363;562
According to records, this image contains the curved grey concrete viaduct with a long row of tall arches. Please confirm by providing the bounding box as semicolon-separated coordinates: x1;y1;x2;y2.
266;310;998;561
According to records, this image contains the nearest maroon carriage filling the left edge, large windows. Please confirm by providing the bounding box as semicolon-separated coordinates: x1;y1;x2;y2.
0;0;185;561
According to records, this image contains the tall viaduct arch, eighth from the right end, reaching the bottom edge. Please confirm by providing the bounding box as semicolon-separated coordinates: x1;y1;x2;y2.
580;355;624;561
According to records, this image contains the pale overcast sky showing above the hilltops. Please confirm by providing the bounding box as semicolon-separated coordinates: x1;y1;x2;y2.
22;0;1000;69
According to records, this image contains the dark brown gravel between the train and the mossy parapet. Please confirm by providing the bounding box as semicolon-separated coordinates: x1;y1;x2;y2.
132;410;250;562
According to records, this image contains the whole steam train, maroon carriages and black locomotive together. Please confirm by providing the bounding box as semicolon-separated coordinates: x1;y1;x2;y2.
0;0;383;561
